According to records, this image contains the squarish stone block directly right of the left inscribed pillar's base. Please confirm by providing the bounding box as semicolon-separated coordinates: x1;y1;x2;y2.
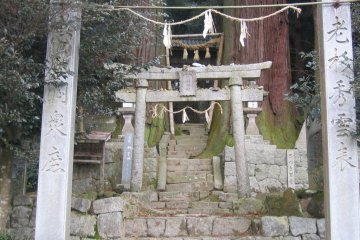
70;213;96;237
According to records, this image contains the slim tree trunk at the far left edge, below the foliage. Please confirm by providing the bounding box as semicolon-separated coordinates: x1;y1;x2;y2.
0;148;13;230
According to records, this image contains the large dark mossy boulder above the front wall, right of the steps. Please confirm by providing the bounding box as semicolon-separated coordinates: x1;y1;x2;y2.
265;189;303;217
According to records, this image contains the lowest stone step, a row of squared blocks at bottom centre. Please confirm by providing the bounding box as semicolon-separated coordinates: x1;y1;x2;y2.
125;216;251;239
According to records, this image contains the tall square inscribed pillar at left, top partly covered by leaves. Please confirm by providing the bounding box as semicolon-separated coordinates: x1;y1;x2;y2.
35;0;81;240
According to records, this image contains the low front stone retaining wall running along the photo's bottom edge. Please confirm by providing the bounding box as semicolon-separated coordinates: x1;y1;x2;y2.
8;192;325;240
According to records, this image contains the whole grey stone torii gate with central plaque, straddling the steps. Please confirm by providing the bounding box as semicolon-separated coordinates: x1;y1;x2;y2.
116;62;272;197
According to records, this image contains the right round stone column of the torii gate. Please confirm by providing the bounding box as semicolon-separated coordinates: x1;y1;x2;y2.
229;72;250;197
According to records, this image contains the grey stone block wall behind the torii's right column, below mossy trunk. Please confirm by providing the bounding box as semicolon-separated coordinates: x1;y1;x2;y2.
223;135;309;194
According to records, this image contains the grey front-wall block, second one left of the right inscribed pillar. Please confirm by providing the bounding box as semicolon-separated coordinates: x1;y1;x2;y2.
289;217;317;236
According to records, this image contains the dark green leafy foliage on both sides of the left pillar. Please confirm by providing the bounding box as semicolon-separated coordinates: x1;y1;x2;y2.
0;0;161;147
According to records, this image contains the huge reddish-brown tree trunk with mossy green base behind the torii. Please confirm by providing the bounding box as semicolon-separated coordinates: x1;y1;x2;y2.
229;0;300;148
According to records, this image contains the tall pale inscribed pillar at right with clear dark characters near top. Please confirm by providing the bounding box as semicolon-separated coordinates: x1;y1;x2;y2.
317;0;360;240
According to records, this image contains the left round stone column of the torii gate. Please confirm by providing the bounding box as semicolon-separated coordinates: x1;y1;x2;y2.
131;79;149;192
